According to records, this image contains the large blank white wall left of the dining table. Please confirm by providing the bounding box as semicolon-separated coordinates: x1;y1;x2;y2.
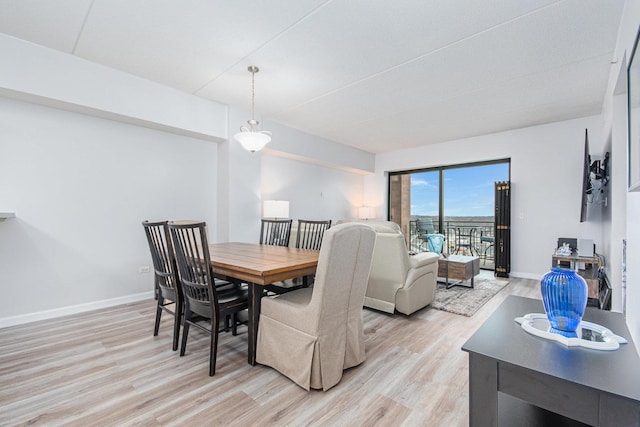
0;98;217;324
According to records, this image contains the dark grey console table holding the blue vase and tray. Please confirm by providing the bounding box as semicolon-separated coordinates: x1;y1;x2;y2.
462;296;640;427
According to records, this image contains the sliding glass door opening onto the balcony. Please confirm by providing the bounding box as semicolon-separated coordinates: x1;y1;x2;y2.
389;159;510;269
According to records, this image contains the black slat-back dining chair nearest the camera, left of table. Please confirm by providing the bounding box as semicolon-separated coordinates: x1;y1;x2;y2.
168;222;248;376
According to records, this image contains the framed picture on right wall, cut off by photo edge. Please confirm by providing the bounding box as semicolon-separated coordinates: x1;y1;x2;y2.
627;28;640;191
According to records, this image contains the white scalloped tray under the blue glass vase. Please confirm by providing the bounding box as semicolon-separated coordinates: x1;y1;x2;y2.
514;313;627;350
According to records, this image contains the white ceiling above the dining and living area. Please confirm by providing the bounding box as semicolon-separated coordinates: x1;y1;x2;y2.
0;0;624;153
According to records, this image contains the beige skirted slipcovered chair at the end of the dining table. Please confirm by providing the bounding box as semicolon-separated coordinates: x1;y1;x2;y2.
256;224;376;391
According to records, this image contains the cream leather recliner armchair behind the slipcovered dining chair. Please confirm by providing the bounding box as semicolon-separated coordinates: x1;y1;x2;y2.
340;221;440;314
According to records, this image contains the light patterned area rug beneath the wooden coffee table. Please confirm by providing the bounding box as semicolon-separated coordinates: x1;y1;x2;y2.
431;279;509;316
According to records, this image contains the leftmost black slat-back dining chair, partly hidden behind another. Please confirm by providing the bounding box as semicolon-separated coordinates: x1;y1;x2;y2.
142;221;184;351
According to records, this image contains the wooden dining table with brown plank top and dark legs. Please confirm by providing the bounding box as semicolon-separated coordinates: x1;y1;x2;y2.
209;242;320;365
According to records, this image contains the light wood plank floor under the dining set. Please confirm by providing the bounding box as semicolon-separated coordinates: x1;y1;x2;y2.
0;272;539;426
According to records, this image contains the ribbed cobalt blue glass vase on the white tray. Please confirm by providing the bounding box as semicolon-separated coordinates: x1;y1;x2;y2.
540;267;588;338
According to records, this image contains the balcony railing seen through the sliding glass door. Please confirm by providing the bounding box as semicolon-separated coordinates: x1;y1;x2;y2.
409;220;495;270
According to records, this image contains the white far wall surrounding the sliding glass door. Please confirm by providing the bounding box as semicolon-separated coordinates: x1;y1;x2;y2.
365;116;604;279
